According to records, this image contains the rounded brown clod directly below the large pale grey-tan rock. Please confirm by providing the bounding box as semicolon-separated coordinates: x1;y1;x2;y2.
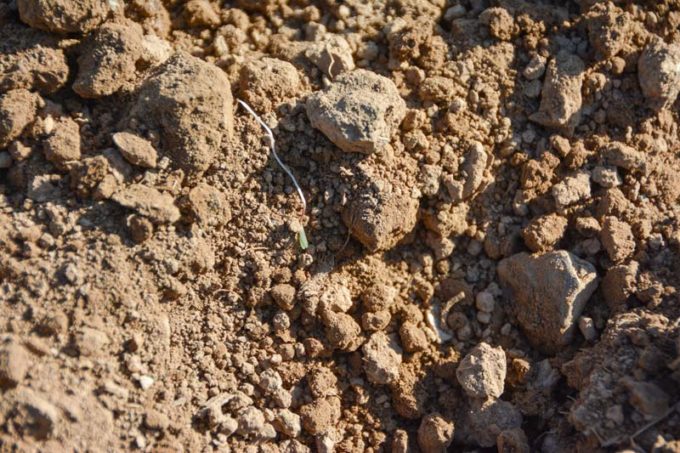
342;176;418;252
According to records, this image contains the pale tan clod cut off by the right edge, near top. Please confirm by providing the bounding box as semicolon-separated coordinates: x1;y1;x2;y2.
638;38;680;110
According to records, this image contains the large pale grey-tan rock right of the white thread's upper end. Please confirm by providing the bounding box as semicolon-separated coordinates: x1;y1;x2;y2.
307;69;406;154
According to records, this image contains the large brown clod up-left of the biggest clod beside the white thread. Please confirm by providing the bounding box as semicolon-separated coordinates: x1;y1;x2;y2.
73;21;144;98
